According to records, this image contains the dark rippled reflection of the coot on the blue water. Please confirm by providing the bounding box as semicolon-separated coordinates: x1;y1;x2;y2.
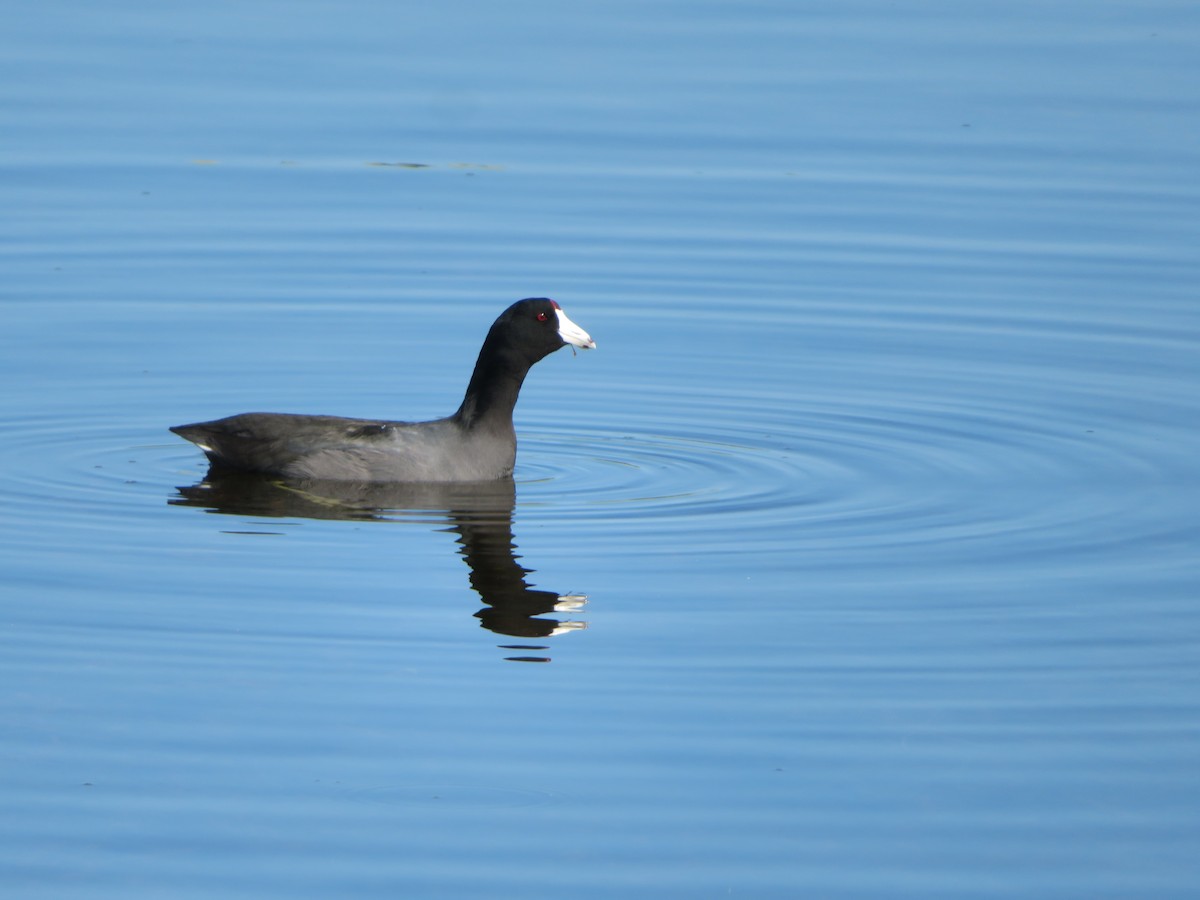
170;468;587;662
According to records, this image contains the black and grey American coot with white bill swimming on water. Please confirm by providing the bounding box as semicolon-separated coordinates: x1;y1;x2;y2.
172;298;596;481
